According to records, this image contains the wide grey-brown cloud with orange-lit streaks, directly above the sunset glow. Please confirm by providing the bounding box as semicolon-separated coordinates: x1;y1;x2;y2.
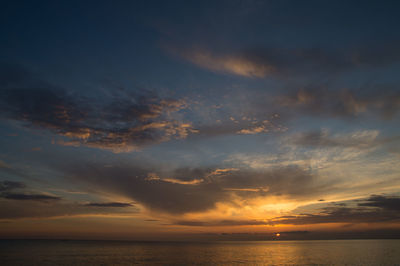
62;163;326;214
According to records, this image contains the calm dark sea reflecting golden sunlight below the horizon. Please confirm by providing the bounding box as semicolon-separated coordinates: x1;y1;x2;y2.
0;240;400;265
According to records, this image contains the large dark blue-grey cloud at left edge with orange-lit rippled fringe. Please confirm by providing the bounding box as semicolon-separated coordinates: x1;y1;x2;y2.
0;63;196;152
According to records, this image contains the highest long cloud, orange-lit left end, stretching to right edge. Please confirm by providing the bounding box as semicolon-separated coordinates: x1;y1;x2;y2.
175;41;400;78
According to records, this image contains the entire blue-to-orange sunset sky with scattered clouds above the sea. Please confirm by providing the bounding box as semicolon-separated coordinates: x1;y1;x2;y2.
0;0;400;240
